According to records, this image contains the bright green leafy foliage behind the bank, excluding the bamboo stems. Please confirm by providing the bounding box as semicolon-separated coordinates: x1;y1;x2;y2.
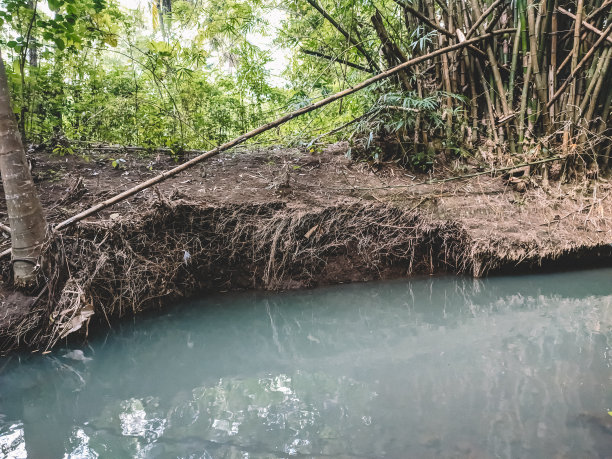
0;0;482;167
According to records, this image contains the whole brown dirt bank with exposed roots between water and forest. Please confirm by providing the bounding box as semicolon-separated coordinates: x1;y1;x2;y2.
0;144;612;352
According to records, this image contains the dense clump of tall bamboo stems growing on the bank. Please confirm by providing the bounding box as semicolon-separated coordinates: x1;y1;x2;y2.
286;0;612;165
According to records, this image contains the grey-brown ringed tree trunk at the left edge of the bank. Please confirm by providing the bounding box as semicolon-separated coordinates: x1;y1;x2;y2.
0;55;46;286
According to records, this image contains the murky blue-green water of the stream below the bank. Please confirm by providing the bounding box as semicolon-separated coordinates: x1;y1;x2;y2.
0;270;612;458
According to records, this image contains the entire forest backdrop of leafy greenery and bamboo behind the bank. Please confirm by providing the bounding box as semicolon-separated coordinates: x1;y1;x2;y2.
0;0;612;169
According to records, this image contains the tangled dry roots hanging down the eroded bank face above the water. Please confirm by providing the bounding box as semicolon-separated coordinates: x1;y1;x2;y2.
0;200;472;351
